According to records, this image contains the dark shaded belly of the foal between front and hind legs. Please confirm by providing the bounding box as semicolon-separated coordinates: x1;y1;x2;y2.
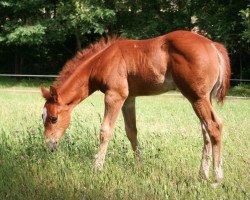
129;75;176;96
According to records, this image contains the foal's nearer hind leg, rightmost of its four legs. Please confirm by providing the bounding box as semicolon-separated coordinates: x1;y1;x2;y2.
193;98;223;183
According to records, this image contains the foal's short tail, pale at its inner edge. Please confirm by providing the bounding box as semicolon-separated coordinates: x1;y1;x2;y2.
213;42;231;103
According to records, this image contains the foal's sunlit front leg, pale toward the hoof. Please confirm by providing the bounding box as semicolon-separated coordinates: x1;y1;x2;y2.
95;91;125;170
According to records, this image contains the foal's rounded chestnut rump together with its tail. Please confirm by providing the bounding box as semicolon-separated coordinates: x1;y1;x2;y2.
166;31;230;102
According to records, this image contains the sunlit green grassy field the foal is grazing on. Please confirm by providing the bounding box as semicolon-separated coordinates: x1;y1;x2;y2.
0;79;250;200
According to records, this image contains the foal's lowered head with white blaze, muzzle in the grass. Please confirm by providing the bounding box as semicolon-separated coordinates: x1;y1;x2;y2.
41;86;72;151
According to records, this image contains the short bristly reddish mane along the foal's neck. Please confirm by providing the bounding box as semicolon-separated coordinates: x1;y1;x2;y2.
53;35;122;88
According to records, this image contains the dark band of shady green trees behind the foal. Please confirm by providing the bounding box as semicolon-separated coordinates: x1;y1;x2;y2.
0;0;250;79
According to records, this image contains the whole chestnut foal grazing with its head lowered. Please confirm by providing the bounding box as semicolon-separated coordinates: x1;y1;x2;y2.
41;31;230;183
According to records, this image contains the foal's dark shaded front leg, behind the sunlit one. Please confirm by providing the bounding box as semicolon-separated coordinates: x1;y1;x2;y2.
122;97;140;160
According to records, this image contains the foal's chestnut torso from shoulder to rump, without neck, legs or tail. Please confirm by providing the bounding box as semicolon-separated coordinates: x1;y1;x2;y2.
93;31;218;96
